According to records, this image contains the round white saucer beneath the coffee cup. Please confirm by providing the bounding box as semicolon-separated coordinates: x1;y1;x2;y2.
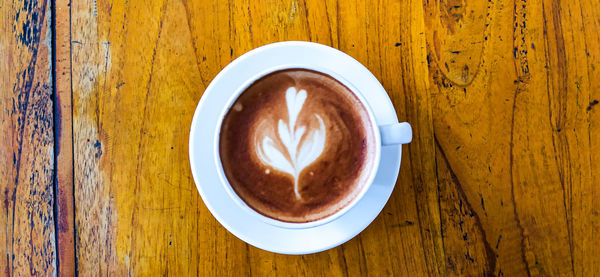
189;41;402;254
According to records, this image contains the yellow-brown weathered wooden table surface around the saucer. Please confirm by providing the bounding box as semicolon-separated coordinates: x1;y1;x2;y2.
0;0;600;276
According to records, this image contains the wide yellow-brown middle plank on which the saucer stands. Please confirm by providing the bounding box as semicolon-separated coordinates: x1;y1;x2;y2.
72;1;426;275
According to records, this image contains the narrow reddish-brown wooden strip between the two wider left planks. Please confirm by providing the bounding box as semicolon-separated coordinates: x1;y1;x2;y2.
54;0;75;276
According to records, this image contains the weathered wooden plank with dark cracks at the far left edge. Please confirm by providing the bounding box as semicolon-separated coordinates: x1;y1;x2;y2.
0;1;56;276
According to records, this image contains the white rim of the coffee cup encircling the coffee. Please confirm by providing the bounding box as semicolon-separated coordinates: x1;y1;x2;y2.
213;45;382;229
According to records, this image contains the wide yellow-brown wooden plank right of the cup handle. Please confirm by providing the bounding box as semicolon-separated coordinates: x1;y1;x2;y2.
425;1;600;276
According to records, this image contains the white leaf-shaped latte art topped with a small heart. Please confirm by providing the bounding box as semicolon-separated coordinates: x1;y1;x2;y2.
256;87;326;199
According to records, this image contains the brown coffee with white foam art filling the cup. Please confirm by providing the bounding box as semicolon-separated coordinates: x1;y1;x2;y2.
219;69;376;223
